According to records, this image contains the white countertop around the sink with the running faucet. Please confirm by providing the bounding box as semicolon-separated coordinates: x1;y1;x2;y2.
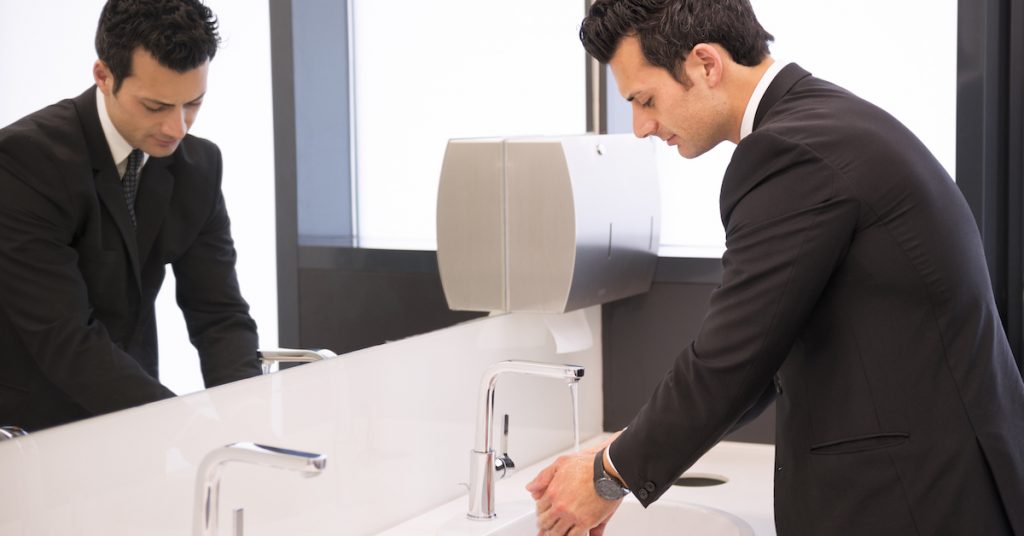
380;435;775;536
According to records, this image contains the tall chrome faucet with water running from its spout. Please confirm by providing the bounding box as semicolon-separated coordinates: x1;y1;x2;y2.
466;361;584;520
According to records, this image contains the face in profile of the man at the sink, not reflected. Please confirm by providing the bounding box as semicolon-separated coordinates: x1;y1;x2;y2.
608;36;727;158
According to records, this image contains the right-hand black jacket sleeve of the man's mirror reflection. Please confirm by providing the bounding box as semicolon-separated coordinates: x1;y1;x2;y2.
173;153;260;387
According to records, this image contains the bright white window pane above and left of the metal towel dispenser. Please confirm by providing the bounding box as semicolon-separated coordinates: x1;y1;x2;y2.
351;0;586;249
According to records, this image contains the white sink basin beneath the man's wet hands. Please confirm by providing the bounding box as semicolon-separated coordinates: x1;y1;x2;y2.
437;497;754;536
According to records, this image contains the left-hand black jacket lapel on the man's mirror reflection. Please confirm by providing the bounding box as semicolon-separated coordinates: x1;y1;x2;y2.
74;86;142;290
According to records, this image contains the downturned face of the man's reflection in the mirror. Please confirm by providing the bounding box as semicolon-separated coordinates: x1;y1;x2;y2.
93;47;210;157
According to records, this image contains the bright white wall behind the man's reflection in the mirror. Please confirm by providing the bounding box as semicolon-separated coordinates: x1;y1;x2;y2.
0;0;278;394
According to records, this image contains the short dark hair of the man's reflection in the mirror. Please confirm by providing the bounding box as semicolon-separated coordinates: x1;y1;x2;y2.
96;0;220;92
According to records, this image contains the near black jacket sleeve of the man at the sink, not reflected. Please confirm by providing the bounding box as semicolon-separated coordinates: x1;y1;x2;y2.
612;132;859;506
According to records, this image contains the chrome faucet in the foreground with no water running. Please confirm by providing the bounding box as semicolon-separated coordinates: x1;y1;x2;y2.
193;443;327;536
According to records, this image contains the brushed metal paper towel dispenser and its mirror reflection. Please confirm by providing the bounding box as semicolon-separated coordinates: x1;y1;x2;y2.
437;134;660;313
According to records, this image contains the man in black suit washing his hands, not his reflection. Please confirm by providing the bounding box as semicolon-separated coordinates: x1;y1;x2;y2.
528;0;1024;536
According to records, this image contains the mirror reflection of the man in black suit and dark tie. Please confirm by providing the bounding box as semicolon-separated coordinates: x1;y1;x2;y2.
0;0;260;429
